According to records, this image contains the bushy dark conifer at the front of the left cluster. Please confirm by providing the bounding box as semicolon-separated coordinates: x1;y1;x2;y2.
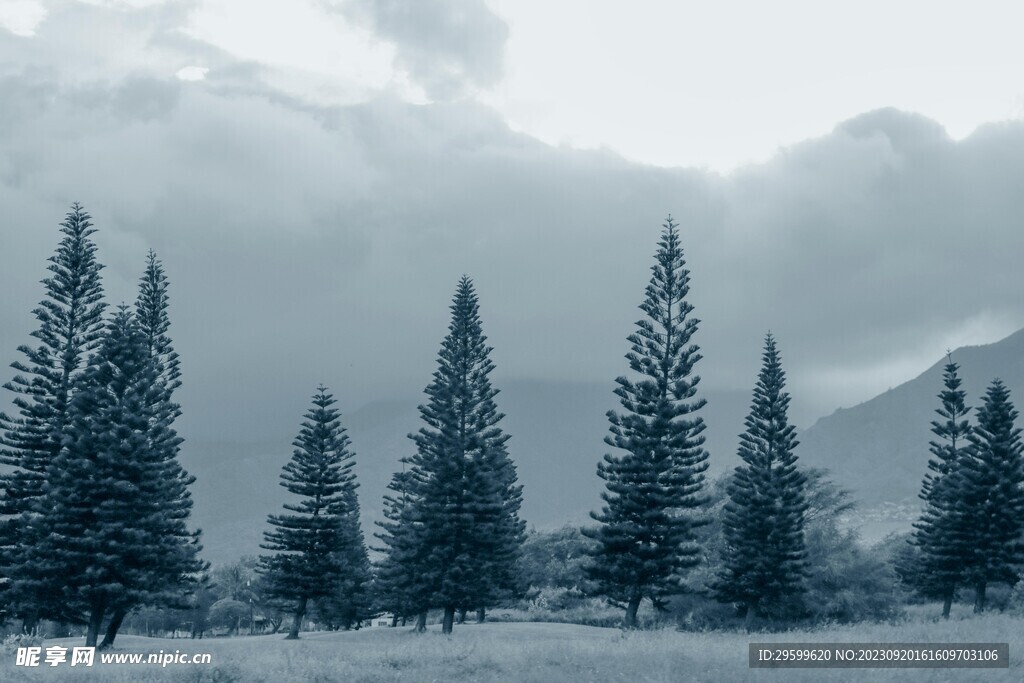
26;307;205;645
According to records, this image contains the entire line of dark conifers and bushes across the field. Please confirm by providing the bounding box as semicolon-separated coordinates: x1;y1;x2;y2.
0;205;1024;646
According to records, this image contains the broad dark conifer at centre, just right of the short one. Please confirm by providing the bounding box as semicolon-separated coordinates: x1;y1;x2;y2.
391;276;525;634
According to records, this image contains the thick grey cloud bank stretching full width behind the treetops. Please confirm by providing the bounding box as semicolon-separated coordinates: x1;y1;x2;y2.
6;1;1024;439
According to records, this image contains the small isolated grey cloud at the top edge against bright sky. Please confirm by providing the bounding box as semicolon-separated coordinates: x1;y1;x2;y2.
337;0;508;100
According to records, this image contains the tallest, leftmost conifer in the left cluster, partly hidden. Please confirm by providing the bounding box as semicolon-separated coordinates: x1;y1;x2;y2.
0;204;104;631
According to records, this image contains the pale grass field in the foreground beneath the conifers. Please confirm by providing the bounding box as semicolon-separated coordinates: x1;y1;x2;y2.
0;614;1024;683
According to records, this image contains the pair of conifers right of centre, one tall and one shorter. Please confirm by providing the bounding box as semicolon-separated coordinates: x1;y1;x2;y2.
584;216;807;628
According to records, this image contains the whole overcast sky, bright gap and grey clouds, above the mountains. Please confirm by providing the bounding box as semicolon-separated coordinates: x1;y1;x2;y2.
0;0;1024;438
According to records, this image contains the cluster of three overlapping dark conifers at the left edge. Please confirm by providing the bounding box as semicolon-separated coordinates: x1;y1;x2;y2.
0;204;205;646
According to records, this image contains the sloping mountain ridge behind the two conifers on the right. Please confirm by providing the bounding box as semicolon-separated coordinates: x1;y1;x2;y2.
797;330;1024;506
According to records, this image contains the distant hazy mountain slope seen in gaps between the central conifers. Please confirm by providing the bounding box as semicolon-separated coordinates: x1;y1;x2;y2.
181;380;750;562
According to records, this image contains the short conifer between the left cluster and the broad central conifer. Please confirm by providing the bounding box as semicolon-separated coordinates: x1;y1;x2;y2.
260;386;369;639
